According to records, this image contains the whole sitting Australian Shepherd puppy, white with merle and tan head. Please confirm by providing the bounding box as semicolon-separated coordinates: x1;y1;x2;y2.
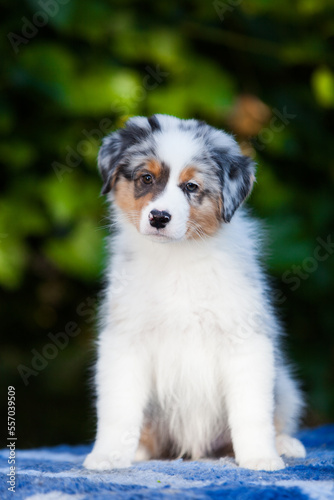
84;115;305;471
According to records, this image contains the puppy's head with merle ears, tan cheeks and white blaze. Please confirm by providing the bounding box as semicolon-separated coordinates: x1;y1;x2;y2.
98;115;255;241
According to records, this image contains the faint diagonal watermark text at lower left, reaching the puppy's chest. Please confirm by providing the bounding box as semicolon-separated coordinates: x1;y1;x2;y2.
17;269;133;386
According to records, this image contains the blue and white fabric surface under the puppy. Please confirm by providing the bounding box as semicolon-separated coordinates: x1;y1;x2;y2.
0;425;334;500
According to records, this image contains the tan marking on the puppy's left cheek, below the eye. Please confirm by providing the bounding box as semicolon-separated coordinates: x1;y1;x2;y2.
115;177;153;230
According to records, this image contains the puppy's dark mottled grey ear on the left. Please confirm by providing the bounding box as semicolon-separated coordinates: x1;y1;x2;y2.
98;131;123;194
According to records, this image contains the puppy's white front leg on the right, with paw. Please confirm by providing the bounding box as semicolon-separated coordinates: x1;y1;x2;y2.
225;333;284;471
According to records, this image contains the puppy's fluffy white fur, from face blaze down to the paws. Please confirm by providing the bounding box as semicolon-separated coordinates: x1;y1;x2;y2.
85;115;305;470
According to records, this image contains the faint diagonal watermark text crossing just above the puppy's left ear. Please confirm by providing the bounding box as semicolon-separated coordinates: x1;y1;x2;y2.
51;65;169;182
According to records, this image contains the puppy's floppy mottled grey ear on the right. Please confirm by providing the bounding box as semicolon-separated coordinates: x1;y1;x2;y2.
215;151;255;222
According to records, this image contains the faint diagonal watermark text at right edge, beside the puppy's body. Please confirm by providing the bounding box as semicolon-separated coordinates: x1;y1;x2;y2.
275;234;334;304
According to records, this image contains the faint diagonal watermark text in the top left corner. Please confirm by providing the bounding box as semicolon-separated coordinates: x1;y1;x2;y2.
7;0;70;54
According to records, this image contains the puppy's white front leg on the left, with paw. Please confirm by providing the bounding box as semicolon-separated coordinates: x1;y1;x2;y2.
84;332;148;470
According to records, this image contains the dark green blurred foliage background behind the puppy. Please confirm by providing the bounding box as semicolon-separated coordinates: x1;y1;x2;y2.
0;0;334;447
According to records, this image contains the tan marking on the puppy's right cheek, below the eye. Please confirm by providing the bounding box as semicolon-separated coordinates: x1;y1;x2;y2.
186;198;222;239
